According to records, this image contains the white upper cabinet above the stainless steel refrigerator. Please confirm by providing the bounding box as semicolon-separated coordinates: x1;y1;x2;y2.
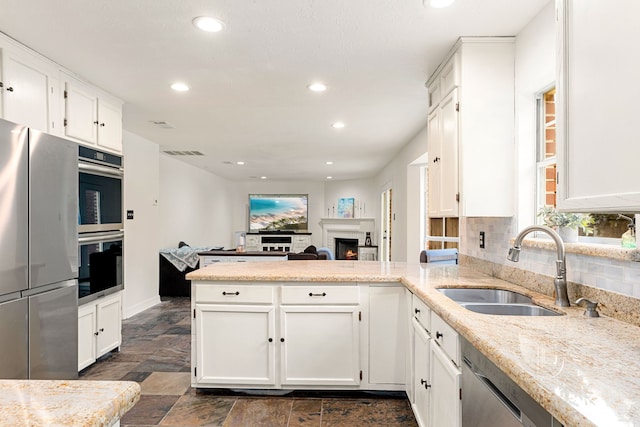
0;37;60;133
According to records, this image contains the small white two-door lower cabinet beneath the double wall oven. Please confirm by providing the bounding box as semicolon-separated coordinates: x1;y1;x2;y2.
78;292;122;371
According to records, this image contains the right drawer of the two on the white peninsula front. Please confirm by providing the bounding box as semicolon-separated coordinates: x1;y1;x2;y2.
282;284;360;305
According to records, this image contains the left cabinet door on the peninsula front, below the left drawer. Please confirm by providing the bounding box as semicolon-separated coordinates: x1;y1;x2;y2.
194;304;276;386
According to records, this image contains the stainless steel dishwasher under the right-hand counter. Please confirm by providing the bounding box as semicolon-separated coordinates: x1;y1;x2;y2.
460;337;562;427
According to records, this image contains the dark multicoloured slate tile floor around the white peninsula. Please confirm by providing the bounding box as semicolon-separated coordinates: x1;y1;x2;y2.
80;298;417;427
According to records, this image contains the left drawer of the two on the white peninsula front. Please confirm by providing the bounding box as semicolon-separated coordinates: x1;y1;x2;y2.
196;283;275;304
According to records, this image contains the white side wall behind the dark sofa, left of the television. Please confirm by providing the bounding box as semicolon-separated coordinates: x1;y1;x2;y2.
158;154;236;248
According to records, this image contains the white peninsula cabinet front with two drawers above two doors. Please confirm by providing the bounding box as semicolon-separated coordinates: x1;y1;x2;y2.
192;282;361;389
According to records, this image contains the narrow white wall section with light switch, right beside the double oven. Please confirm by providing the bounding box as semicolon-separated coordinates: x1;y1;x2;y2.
122;131;160;318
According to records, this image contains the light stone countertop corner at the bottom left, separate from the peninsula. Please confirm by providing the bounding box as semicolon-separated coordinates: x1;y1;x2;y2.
0;380;140;427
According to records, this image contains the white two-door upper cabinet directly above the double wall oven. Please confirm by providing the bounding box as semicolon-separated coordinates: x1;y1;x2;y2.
64;75;122;153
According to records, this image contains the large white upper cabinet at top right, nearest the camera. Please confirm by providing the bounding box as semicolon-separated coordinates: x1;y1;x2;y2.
556;0;640;212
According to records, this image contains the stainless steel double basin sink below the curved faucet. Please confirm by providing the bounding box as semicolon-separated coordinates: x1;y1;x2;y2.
438;288;562;316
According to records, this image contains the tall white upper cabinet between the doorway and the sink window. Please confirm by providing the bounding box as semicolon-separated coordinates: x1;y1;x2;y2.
427;37;515;217
